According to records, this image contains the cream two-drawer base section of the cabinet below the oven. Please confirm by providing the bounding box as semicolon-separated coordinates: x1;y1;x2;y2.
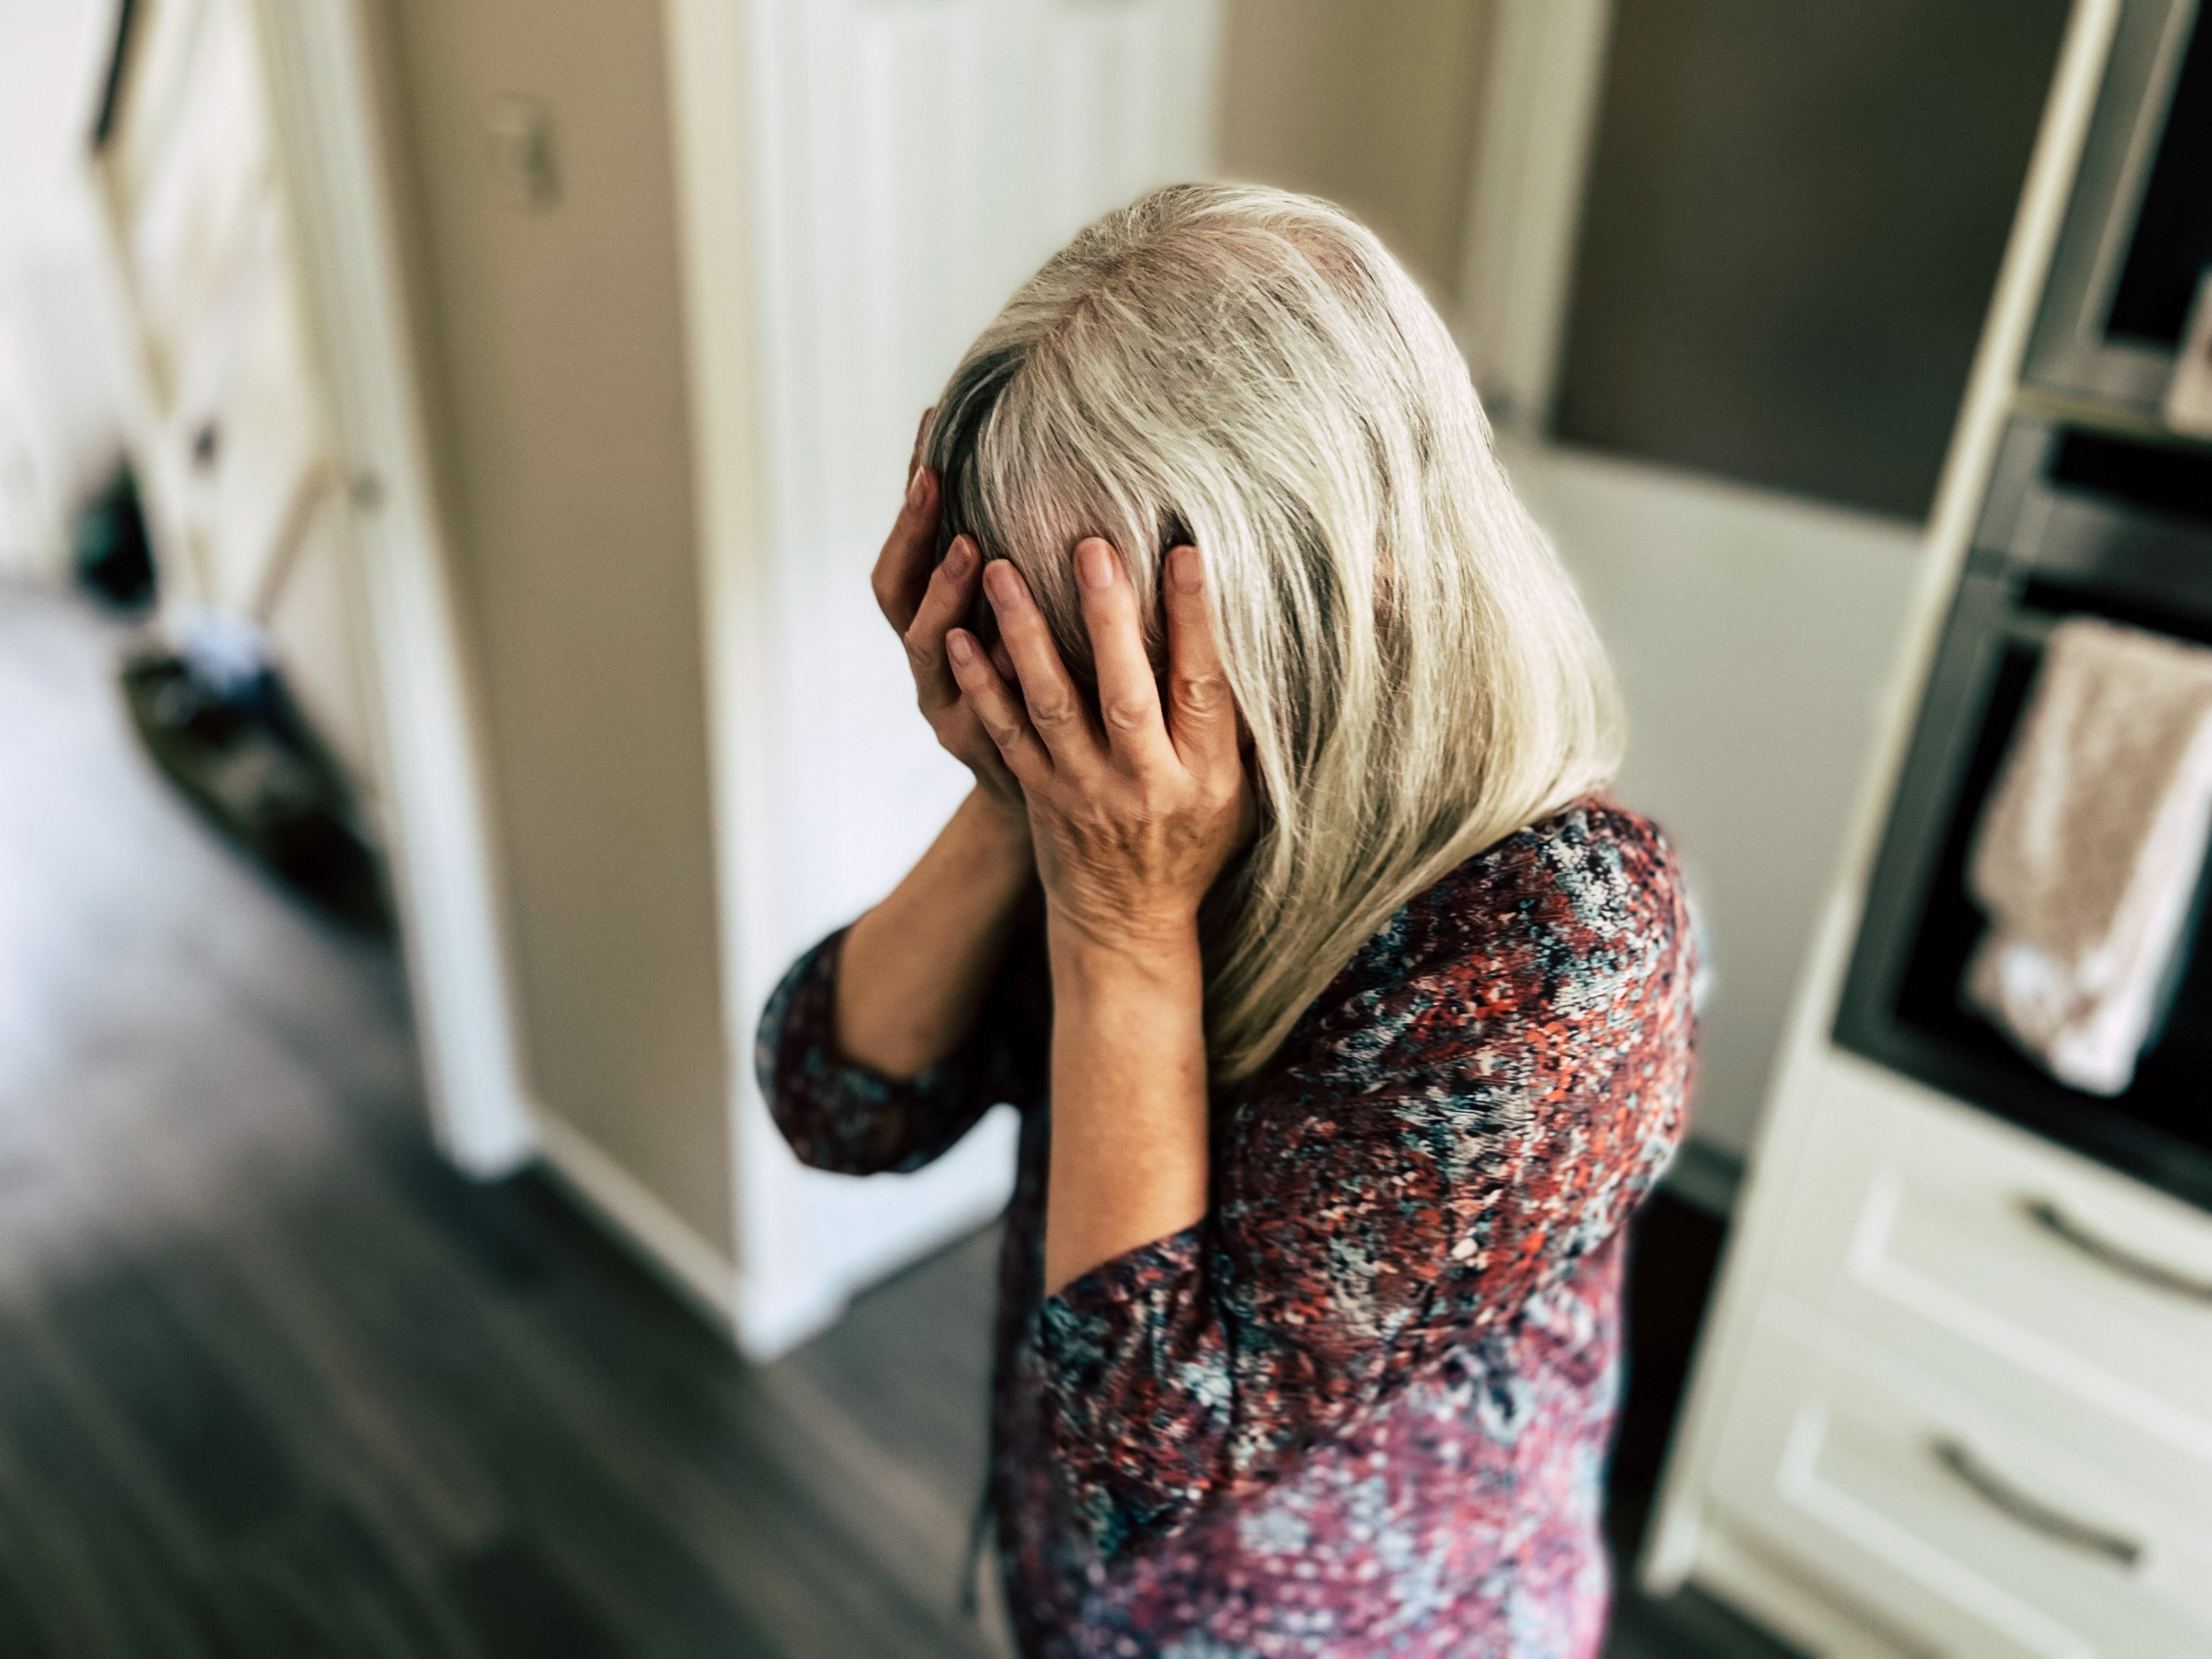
1670;1055;2212;1657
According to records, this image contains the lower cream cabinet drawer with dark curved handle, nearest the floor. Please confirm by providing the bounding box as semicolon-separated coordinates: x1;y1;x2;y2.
1710;1316;2212;1659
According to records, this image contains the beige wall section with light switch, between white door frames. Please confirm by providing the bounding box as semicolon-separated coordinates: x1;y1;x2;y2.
387;0;732;1250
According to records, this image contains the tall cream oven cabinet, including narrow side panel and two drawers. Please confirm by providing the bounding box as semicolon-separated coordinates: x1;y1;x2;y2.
1641;0;2212;1659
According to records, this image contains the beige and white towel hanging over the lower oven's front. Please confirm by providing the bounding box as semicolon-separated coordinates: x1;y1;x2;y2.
1964;617;2212;1095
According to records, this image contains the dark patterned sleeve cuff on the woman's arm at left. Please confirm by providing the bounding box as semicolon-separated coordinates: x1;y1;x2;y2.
754;929;1042;1175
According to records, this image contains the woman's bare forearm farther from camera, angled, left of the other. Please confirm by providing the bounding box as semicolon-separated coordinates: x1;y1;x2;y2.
836;789;1035;1080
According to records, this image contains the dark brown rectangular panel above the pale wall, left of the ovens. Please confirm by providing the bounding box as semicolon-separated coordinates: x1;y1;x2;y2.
1555;0;2068;517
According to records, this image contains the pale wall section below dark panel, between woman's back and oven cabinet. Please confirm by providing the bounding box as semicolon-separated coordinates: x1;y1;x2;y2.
1506;444;1920;1155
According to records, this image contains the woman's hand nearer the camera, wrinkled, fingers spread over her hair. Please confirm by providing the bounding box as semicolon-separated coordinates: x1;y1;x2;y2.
945;538;1256;951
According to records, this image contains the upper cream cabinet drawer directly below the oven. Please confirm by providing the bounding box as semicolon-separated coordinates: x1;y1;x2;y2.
1770;1059;2212;1480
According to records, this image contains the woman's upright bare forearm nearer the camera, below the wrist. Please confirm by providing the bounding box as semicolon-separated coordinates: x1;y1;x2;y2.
1044;922;1207;1294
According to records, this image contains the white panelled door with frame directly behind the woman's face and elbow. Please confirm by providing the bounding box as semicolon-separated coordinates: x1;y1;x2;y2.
670;0;1219;1350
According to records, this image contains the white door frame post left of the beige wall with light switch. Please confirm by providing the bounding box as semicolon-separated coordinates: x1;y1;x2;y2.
252;0;538;1179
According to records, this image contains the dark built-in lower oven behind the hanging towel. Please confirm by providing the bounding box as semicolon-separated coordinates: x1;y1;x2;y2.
1836;420;2212;1210
